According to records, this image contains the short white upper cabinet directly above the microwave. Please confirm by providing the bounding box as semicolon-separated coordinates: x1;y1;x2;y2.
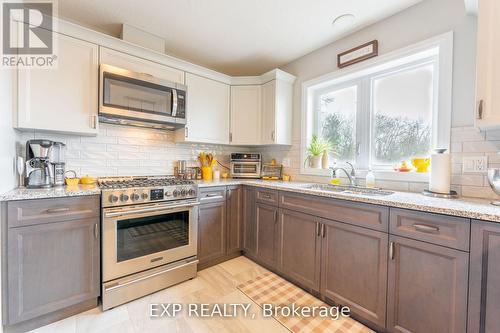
100;47;184;84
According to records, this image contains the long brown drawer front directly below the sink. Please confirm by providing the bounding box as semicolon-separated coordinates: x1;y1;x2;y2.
279;192;389;232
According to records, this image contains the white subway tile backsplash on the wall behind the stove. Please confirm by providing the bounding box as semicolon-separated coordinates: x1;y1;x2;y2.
17;124;250;177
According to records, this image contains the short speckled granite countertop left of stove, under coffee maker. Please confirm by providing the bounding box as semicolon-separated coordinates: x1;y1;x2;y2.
0;185;101;201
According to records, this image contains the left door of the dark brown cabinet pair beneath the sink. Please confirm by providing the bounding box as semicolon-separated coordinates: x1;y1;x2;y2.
277;209;321;292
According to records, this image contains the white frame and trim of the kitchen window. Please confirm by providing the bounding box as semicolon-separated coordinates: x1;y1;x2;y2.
300;31;453;182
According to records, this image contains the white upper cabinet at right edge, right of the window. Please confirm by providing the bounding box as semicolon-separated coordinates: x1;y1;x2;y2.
476;0;500;129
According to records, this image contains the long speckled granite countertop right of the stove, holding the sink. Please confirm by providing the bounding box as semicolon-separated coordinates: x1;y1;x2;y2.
198;179;500;222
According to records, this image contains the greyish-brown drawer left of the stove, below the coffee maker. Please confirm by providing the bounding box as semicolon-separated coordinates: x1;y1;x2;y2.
7;195;101;228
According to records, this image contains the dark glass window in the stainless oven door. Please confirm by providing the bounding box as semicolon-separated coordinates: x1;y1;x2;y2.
116;211;189;262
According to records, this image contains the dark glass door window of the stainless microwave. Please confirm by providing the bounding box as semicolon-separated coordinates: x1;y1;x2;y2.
103;72;172;116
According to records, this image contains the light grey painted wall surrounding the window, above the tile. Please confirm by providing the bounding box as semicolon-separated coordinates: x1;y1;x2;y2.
282;0;477;134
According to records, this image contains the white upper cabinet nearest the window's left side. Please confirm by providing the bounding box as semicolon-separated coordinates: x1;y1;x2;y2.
261;79;293;145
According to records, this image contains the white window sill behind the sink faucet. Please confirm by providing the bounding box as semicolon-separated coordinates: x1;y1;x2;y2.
300;168;429;183
